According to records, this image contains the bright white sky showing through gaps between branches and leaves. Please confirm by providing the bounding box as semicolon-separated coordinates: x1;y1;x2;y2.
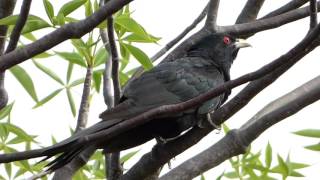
6;0;320;179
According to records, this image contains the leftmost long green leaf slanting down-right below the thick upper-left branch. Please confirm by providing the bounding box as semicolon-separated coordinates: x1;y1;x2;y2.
10;65;38;102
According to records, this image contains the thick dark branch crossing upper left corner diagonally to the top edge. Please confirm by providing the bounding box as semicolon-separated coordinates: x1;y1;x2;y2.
0;0;133;71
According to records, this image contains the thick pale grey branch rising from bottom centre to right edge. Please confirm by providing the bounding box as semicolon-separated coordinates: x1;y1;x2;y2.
160;76;320;180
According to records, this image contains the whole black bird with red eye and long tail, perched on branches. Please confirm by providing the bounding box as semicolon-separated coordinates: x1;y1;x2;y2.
0;34;249;170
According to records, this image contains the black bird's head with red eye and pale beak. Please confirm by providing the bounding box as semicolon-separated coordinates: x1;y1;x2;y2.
188;34;251;68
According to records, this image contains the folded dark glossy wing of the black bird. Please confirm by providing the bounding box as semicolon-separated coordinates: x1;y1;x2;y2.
100;57;224;120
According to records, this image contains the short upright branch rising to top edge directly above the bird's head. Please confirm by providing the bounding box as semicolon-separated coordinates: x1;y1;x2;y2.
205;0;220;31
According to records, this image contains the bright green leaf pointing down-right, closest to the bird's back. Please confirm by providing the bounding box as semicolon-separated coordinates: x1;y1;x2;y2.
122;43;153;70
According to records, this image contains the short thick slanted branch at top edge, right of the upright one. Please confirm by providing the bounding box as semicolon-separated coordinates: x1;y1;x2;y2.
236;0;265;24
